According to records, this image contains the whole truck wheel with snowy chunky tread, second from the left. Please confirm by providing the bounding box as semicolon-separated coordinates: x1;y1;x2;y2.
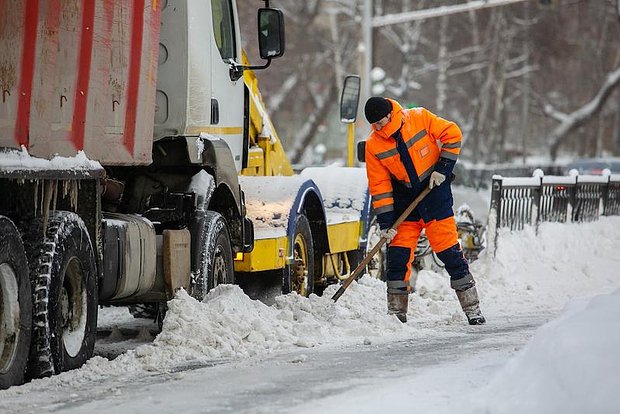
26;211;97;378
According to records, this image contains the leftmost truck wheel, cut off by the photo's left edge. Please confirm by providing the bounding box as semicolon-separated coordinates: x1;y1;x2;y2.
0;217;32;389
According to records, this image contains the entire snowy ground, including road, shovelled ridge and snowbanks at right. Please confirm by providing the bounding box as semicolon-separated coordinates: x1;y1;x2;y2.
0;217;620;413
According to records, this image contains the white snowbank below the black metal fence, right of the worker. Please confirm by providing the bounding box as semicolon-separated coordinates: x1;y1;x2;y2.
471;217;620;316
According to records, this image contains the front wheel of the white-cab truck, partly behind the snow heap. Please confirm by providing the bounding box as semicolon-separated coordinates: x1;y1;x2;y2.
191;211;235;301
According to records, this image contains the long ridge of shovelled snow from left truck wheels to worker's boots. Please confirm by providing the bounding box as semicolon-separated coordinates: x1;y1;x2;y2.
3;272;465;395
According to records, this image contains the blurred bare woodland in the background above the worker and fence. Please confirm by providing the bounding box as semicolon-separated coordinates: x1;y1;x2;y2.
240;0;620;163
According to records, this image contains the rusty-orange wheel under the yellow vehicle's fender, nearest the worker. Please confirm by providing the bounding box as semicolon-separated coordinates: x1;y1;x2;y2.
282;214;314;296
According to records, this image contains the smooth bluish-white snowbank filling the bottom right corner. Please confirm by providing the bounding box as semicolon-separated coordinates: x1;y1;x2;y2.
479;289;620;414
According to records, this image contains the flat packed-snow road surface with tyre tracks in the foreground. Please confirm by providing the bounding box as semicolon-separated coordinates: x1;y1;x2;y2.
0;314;550;413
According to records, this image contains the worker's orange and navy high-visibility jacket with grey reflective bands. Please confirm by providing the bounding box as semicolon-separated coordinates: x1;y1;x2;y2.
366;99;462;228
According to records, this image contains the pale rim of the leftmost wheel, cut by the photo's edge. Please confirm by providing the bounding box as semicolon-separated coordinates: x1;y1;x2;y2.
0;263;20;373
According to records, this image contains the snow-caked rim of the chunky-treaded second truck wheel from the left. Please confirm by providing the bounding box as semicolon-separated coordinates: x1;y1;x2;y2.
59;257;87;357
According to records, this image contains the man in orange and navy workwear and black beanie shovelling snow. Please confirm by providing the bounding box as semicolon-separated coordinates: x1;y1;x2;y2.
364;96;485;325
